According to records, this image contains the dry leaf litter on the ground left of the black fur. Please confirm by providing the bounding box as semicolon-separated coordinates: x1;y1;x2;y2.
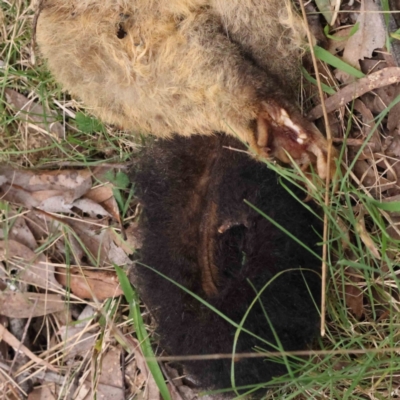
0;165;145;399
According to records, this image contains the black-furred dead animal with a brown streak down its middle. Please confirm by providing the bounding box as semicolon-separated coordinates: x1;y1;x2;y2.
134;135;321;389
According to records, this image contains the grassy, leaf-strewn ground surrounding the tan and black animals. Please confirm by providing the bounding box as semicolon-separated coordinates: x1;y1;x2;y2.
0;0;400;400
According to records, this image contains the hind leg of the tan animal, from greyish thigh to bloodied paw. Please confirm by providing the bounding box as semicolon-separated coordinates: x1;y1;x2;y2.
211;0;335;178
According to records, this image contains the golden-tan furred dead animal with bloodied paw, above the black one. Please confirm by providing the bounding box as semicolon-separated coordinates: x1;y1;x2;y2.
37;0;327;177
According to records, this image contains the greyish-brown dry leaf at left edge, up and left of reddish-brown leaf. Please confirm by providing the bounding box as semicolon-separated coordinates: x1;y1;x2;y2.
0;240;61;290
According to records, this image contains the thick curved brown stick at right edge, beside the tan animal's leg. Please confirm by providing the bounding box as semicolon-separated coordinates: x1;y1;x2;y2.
308;67;400;121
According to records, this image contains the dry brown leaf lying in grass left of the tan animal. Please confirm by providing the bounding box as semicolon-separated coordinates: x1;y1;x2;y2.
4;88;64;138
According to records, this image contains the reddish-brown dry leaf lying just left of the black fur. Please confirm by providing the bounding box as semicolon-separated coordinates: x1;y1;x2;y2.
57;267;123;301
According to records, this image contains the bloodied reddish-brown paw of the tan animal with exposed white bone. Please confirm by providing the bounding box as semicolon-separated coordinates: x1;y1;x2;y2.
255;101;336;179
